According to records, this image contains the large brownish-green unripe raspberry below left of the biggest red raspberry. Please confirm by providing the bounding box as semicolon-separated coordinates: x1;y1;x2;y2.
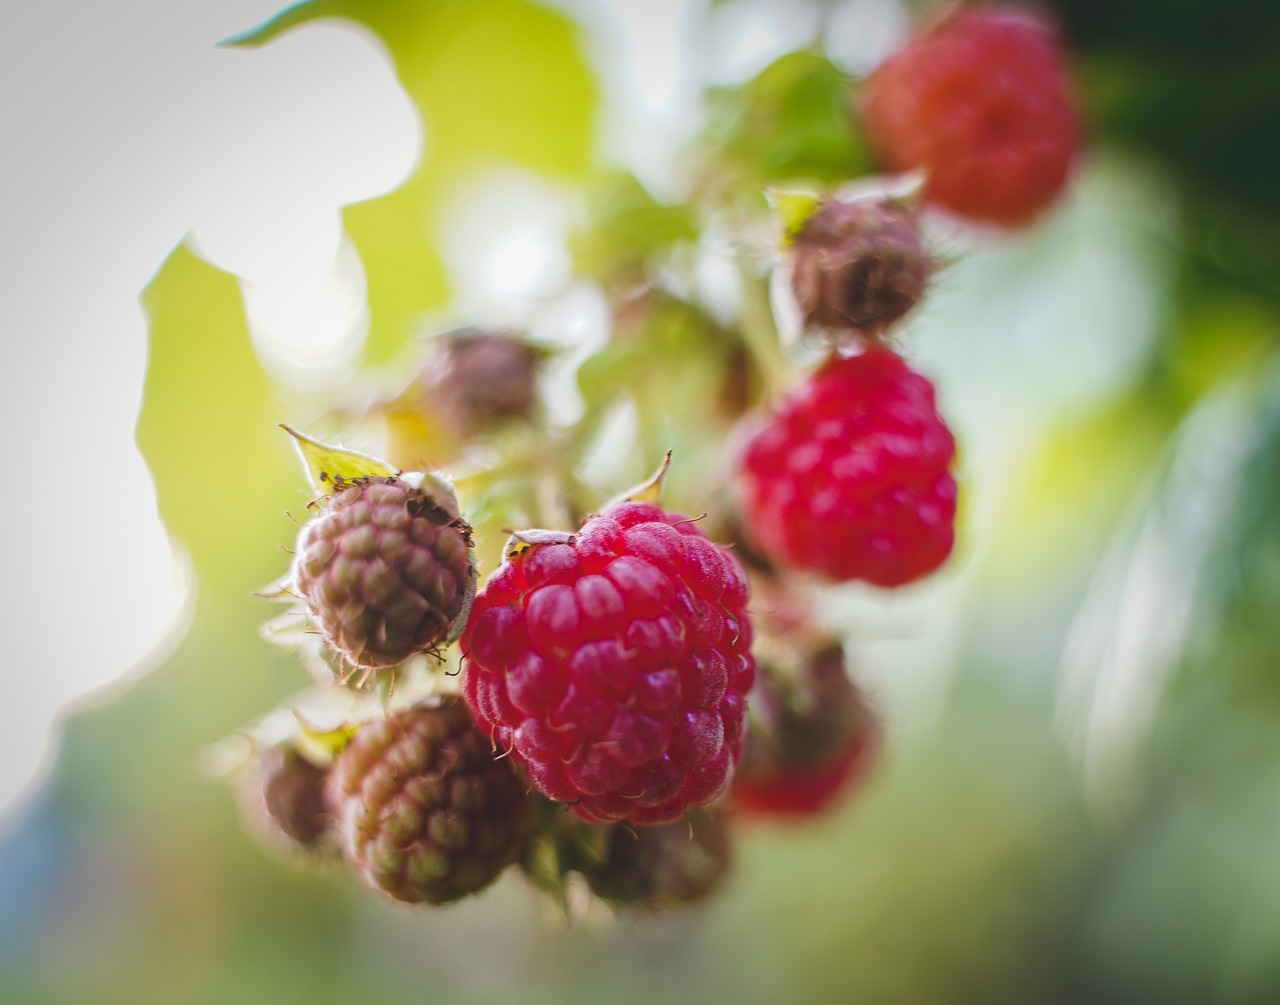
329;698;530;904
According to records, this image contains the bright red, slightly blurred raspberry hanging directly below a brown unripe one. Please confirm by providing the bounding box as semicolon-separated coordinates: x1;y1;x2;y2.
739;346;956;586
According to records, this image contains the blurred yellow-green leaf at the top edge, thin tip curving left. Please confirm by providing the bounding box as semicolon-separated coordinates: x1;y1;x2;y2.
227;0;598;364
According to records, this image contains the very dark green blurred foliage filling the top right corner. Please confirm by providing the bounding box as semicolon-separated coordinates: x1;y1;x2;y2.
1053;0;1280;297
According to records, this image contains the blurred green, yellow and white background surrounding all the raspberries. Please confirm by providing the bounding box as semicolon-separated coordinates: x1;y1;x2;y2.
0;0;1280;1005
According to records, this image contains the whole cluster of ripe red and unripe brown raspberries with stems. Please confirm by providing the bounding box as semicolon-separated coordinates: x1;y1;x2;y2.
225;3;1078;909
